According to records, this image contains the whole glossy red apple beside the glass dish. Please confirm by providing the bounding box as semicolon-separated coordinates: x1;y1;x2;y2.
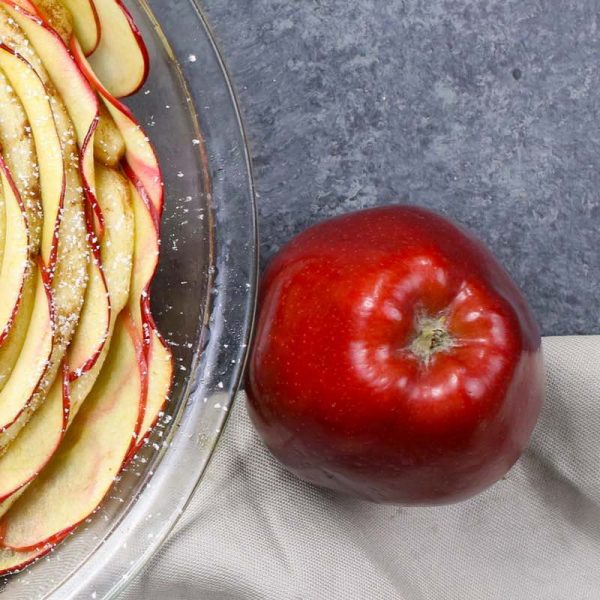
247;206;543;505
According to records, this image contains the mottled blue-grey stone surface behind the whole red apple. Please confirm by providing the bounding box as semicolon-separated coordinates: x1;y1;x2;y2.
204;0;600;334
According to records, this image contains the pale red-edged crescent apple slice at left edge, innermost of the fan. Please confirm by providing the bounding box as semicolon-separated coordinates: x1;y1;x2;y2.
0;156;29;344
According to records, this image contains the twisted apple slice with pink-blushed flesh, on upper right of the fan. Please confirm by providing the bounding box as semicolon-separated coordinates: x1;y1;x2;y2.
71;38;164;222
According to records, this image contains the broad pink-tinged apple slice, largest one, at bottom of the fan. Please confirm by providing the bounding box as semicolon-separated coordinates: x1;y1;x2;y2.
0;313;141;551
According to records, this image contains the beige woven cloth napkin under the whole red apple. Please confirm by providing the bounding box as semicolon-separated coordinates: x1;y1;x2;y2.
120;336;600;600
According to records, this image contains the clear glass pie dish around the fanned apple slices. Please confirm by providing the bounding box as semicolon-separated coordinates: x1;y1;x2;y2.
0;0;257;600
